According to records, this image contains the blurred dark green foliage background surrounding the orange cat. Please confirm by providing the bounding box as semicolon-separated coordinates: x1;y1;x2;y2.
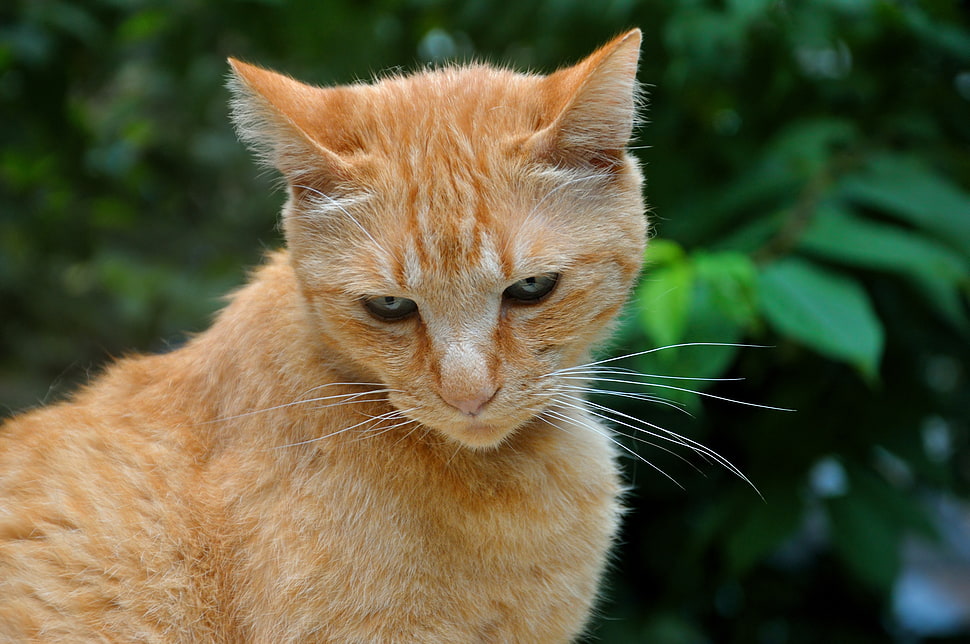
0;0;970;644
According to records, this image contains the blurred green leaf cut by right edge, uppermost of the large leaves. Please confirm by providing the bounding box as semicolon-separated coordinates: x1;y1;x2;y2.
842;154;970;256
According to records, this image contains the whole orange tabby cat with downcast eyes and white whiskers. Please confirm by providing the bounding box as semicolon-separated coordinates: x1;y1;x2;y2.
0;31;645;642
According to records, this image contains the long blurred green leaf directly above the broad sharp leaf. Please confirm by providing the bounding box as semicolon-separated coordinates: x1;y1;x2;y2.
800;205;970;327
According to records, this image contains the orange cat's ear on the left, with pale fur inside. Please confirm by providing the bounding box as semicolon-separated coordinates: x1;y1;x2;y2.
228;58;352;191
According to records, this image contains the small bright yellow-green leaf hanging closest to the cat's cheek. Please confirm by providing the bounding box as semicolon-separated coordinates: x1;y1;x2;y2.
637;260;694;345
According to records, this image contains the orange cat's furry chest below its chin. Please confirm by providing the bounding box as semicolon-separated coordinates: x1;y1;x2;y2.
221;422;618;641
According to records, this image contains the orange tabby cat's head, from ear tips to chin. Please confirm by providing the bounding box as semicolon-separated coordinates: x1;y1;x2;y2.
230;30;646;447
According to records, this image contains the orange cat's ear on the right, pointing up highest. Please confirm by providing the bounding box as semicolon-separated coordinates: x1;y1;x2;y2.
526;29;641;169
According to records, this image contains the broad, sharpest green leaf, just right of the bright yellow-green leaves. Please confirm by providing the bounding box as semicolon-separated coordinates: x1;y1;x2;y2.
759;258;883;378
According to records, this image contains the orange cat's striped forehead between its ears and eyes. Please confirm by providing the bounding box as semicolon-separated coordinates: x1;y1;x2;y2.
344;101;560;291
